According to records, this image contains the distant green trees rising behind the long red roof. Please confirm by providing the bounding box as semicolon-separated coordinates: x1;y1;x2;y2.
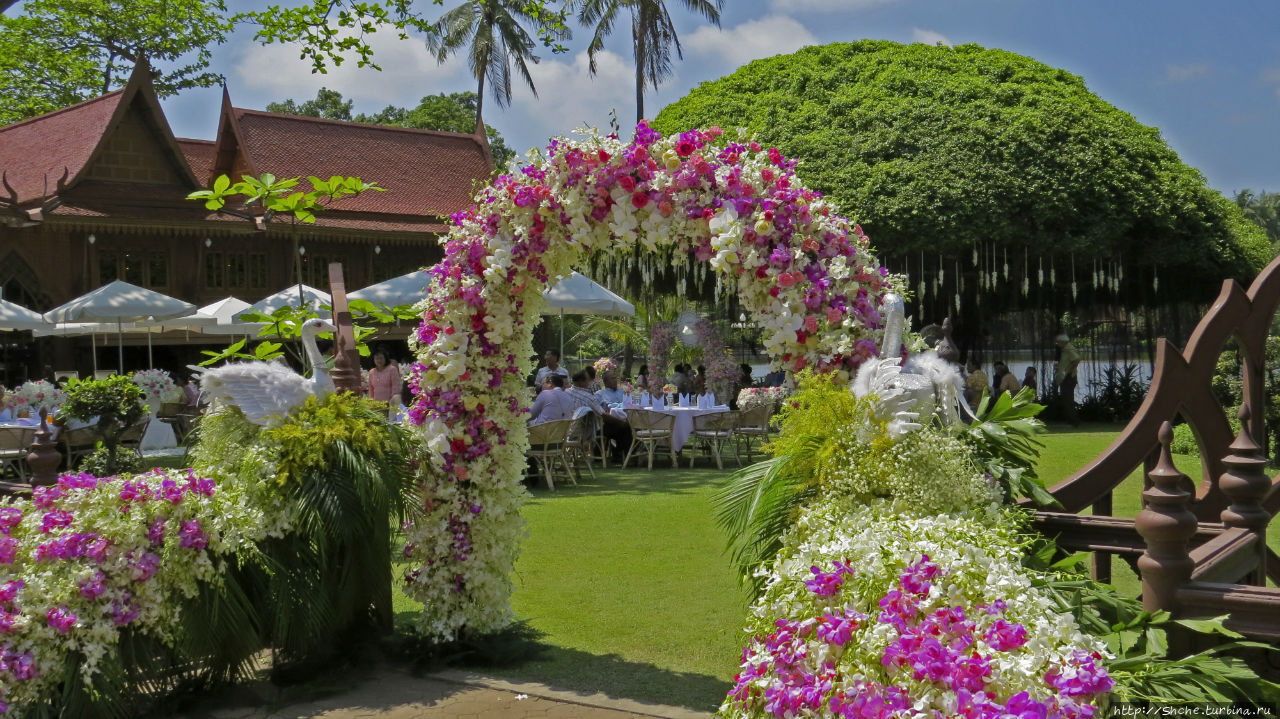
266;87;516;168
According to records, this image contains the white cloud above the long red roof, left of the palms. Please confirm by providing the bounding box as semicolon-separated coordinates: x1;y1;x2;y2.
230;31;466;111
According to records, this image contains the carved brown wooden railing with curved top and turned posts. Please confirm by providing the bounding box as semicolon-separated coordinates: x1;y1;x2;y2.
1036;252;1280;640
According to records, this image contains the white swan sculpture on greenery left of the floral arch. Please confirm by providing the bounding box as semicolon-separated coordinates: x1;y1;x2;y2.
191;317;337;427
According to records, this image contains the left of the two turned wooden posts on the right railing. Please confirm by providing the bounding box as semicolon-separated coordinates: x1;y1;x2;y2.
1134;422;1197;612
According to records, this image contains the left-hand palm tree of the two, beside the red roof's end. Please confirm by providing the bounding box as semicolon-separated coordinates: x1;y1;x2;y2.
426;0;560;127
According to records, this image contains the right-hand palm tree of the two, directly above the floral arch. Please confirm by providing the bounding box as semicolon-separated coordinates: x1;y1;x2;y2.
577;0;724;124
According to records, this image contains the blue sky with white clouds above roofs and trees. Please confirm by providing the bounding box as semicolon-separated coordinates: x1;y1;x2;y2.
164;0;1280;194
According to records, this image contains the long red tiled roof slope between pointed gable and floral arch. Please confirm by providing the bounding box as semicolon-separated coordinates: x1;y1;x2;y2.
233;107;493;216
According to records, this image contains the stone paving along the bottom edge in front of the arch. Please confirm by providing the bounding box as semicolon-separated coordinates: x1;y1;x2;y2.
179;668;710;719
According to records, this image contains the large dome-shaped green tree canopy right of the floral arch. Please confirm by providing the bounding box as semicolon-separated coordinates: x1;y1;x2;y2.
654;41;1271;292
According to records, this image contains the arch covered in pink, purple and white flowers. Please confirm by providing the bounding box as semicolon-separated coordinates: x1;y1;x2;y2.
404;123;890;638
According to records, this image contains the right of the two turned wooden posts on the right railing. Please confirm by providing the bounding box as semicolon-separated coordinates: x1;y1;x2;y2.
1217;402;1271;586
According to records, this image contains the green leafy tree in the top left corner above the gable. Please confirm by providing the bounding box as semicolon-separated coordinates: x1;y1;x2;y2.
0;0;230;123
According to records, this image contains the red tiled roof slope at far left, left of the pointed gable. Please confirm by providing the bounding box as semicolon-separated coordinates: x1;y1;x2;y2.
0;90;124;203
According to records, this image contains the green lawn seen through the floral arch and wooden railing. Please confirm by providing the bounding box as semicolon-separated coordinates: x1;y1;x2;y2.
384;425;1280;710
